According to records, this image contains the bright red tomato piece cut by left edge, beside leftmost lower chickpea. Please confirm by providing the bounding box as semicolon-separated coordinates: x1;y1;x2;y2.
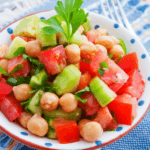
0;81;13;99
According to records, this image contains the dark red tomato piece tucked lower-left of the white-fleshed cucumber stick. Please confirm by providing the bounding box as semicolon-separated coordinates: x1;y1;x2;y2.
78;92;100;116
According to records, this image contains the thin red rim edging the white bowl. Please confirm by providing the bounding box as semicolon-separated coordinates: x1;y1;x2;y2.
0;9;150;150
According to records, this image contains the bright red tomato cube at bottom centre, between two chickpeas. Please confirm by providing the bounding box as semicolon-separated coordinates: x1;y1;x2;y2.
53;118;79;144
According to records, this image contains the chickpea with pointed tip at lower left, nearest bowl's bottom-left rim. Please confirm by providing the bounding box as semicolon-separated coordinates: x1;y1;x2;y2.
27;114;48;136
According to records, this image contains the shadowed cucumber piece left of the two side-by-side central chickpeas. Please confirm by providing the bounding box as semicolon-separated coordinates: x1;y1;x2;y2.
26;90;44;115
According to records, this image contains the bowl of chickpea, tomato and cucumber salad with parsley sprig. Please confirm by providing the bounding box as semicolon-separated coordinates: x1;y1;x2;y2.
0;0;150;149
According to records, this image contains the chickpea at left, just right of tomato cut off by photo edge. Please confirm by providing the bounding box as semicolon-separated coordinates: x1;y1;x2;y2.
13;84;32;102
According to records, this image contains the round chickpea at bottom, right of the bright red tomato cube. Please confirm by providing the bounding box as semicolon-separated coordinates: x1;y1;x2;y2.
79;121;103;142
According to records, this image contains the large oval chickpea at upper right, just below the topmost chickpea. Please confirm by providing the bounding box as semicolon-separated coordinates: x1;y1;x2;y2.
95;36;114;49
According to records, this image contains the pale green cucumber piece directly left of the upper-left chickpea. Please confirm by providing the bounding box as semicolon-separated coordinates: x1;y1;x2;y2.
6;37;27;59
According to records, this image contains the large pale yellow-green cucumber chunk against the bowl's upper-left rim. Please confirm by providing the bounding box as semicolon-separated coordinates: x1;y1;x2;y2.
13;15;40;37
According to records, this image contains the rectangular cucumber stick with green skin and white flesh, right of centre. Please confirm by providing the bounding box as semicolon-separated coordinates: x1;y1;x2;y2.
90;77;117;107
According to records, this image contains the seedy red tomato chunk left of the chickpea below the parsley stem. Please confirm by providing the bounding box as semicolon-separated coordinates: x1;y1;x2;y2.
37;45;66;75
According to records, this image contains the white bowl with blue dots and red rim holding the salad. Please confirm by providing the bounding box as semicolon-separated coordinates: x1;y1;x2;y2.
0;10;150;149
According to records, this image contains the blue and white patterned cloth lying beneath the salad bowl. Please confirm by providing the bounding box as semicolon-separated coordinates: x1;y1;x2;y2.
0;0;150;150
